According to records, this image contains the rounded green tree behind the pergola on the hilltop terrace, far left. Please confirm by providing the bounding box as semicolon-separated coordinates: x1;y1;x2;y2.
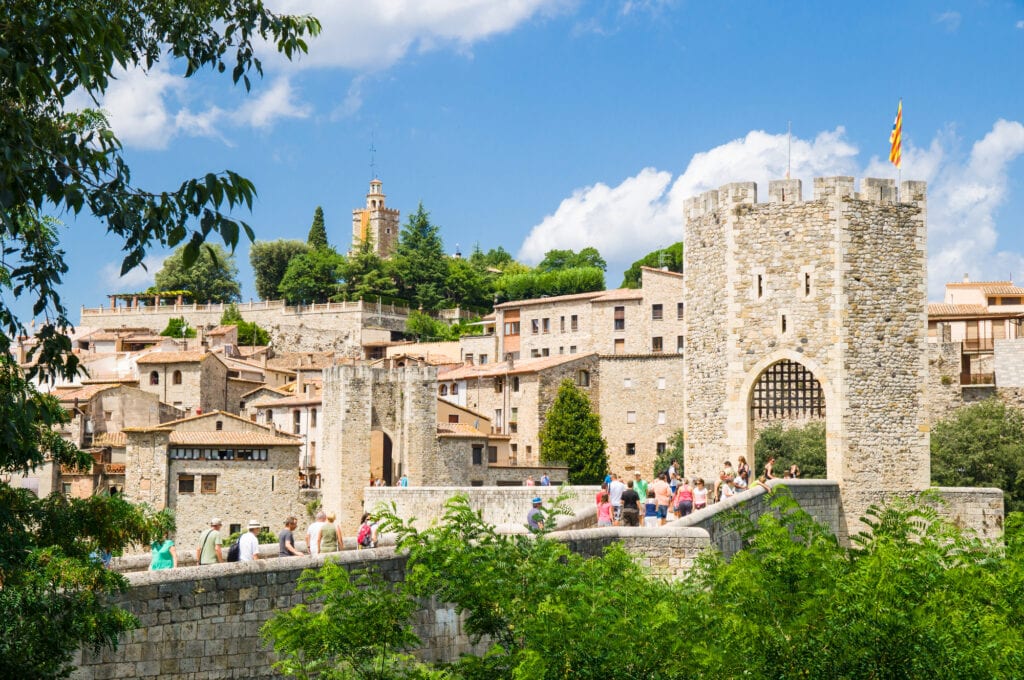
153;244;242;302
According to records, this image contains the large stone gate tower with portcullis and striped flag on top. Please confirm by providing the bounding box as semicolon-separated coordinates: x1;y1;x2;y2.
683;177;930;539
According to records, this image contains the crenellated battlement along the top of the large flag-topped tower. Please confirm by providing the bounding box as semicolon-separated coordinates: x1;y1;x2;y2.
683;176;927;220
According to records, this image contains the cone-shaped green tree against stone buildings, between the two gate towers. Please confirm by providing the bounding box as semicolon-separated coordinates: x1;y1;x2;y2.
540;379;608;484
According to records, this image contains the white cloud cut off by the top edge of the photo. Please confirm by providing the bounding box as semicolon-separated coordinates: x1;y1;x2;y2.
274;0;575;72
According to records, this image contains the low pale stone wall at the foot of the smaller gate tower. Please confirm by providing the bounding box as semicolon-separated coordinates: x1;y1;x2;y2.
365;486;600;532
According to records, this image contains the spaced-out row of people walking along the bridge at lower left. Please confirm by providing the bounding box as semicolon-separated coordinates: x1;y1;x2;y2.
150;510;377;570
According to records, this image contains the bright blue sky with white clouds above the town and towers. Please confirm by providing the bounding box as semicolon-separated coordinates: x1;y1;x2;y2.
63;0;1024;320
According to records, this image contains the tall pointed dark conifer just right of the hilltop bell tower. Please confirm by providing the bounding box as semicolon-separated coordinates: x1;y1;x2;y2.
393;203;449;311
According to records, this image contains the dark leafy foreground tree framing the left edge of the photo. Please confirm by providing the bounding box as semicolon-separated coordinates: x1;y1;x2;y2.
0;0;319;678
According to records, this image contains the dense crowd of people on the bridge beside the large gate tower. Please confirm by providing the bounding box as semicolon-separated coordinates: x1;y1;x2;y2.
594;456;800;526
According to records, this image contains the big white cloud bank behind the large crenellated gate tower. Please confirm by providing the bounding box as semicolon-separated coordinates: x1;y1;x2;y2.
518;120;1024;299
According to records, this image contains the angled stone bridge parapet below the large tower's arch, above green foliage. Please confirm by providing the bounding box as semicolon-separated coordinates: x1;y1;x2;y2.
668;479;843;558
